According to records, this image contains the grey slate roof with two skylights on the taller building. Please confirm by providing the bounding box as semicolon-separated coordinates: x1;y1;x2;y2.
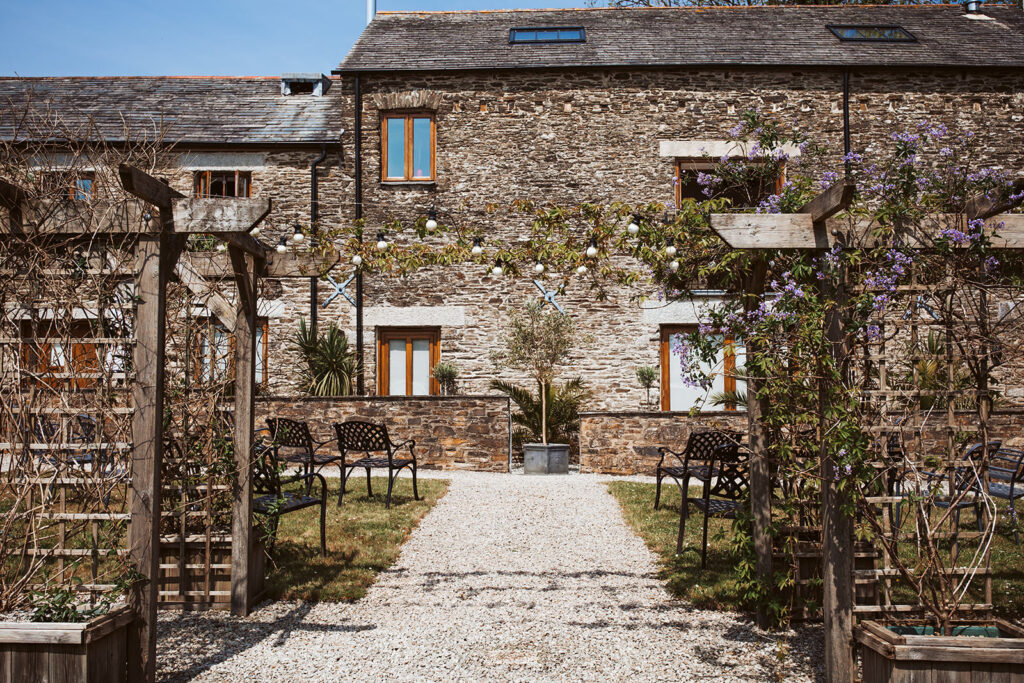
336;5;1024;73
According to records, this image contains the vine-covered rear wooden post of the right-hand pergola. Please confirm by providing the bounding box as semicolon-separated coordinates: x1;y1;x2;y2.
743;254;772;629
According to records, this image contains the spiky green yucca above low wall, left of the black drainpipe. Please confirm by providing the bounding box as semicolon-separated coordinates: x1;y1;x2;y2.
295;318;359;396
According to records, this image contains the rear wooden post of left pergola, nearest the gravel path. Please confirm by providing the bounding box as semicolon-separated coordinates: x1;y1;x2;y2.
228;246;257;616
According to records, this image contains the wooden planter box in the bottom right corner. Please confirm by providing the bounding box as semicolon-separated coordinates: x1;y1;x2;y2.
854;620;1024;683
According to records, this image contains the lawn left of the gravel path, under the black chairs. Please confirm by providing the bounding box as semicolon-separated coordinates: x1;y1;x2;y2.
266;474;449;601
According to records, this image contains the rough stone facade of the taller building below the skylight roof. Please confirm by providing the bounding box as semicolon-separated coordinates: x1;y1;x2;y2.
344;69;1024;411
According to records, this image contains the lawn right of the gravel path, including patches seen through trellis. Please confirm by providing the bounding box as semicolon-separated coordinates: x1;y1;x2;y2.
608;481;1024;621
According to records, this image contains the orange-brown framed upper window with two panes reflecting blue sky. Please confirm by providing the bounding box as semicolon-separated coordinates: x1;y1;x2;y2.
381;114;436;182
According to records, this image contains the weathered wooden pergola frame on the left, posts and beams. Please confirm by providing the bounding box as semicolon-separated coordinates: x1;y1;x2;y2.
0;164;336;681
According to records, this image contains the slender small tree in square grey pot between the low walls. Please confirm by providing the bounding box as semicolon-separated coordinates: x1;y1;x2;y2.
492;301;583;474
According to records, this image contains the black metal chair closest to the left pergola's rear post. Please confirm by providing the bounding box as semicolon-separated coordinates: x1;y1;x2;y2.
253;445;327;556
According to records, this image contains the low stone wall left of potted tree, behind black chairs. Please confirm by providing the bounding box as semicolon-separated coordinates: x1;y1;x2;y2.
256;396;510;472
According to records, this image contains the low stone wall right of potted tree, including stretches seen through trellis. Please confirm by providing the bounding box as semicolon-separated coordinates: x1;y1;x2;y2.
580;409;1024;475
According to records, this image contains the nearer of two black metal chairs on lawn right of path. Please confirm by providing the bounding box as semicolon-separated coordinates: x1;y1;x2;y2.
676;442;750;569
